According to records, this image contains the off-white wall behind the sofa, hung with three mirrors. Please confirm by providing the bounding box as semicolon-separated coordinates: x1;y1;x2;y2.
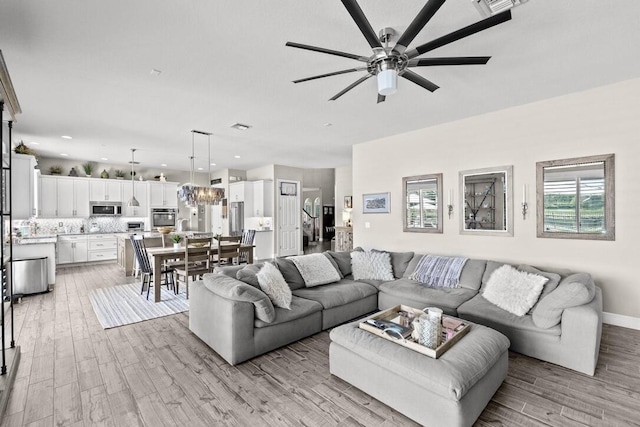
353;79;640;320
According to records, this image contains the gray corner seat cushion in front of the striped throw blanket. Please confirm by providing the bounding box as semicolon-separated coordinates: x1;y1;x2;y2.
380;278;477;313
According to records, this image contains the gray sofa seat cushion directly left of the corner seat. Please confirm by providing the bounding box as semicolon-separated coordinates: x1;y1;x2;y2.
293;279;377;310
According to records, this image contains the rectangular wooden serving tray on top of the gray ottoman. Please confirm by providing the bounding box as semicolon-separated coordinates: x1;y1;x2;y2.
359;305;471;359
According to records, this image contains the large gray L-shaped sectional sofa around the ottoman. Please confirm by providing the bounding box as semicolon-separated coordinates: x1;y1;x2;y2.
189;252;602;375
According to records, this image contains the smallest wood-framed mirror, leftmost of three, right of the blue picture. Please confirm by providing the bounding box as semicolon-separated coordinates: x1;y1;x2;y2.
402;173;442;233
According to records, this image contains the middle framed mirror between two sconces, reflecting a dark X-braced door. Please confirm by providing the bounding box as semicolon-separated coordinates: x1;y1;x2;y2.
460;166;513;236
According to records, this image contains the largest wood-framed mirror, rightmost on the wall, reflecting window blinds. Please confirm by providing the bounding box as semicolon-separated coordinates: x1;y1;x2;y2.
536;154;615;240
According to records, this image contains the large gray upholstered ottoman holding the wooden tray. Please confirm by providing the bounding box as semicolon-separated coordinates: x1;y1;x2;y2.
329;322;509;427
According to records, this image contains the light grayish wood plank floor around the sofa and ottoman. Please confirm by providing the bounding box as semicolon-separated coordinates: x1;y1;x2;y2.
2;264;640;427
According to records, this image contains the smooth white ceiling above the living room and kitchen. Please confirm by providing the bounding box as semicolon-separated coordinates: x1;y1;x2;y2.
0;0;640;170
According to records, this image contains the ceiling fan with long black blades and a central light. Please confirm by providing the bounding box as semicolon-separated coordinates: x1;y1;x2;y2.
286;0;511;103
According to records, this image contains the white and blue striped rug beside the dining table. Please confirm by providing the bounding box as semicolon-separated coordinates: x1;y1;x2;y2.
89;283;189;329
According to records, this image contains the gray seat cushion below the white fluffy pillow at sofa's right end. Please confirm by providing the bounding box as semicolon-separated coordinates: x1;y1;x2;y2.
458;294;561;337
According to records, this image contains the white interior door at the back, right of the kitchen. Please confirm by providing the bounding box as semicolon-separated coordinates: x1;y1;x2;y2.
277;181;302;256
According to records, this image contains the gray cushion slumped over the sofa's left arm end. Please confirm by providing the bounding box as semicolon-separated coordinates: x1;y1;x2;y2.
202;273;276;323
